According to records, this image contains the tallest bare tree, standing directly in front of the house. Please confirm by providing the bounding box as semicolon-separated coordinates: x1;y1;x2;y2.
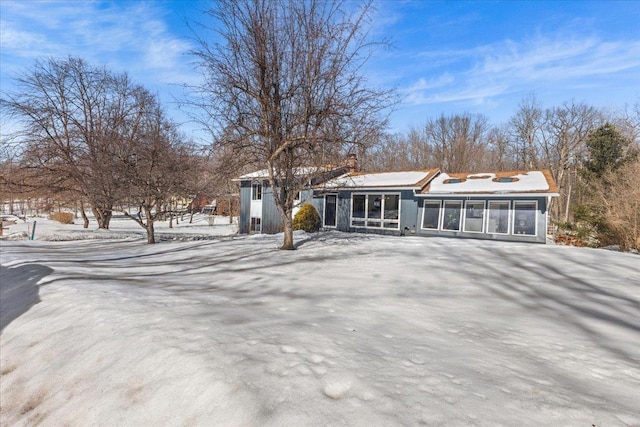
194;0;391;249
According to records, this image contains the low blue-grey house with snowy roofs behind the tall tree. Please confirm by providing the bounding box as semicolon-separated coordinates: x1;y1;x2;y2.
239;160;558;243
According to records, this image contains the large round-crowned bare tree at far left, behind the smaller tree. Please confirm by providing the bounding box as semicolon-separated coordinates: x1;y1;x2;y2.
2;57;148;228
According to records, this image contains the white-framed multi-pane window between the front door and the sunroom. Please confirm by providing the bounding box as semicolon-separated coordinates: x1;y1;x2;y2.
351;194;400;229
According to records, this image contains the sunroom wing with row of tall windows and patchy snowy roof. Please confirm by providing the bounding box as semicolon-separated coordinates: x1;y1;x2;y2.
417;171;557;243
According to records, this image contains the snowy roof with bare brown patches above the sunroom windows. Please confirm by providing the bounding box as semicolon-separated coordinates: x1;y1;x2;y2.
422;170;558;195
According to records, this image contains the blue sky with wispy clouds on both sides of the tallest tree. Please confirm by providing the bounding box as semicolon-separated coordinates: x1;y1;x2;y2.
0;0;640;142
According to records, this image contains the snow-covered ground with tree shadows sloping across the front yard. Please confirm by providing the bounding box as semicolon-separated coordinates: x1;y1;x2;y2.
0;220;640;427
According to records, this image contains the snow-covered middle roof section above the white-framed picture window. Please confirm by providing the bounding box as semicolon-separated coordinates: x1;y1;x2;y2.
325;169;438;188
